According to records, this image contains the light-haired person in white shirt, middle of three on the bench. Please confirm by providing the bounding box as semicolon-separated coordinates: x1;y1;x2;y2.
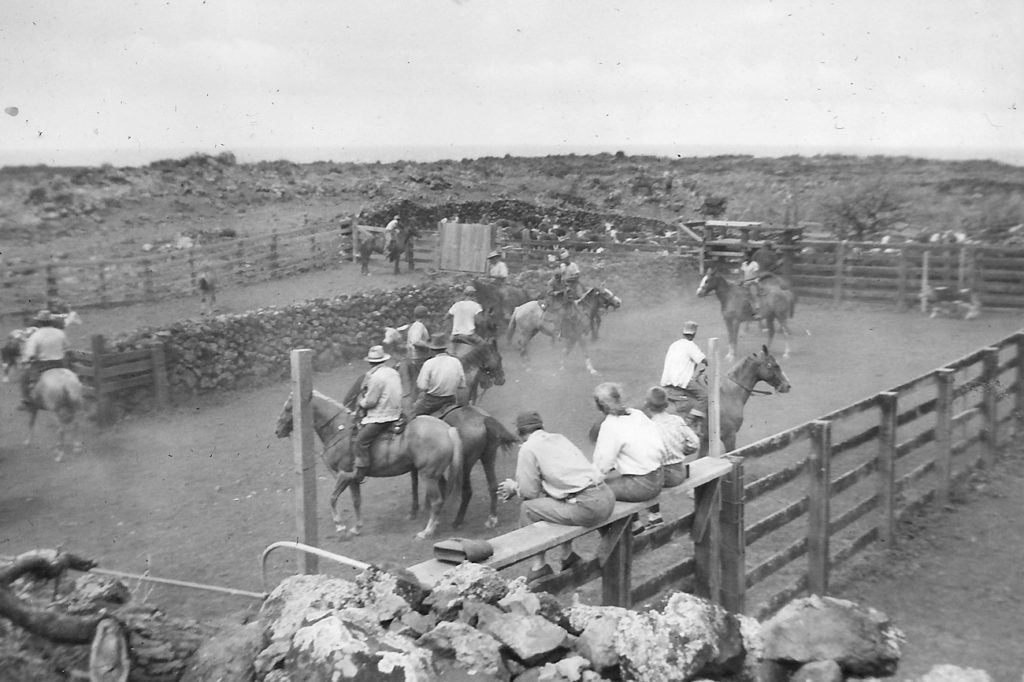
594;382;666;512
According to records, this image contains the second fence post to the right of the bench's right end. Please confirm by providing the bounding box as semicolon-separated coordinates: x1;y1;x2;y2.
807;420;831;595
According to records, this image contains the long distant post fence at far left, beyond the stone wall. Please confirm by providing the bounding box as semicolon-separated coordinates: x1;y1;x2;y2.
0;225;351;315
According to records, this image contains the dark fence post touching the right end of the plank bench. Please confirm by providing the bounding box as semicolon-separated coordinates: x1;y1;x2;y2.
719;455;746;613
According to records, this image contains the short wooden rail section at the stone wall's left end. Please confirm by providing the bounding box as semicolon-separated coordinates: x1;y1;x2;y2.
71;334;170;425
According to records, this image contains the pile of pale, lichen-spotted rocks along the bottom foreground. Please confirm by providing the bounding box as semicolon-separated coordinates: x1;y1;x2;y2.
186;563;902;682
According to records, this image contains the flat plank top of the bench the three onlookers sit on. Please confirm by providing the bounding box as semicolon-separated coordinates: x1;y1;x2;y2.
409;457;733;593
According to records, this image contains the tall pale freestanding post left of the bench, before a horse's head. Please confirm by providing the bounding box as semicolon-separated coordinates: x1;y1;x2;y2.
291;348;317;573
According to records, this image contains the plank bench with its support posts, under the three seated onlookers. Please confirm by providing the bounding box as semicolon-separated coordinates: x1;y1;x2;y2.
409;458;734;606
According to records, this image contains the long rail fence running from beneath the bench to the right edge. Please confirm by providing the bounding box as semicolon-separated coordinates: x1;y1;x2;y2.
395;332;1024;619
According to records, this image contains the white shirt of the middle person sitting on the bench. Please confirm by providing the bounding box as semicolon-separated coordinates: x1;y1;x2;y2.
594;408;666;476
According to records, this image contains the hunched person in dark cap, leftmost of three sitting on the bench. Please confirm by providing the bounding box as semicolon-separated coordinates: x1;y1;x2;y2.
498;412;615;582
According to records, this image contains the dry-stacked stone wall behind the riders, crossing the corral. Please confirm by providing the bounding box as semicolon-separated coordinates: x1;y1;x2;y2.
103;246;693;413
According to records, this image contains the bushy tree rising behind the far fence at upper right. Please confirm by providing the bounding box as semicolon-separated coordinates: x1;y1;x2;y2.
822;179;905;242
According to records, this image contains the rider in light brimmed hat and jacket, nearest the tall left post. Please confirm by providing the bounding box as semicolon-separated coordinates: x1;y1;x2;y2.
352;346;401;483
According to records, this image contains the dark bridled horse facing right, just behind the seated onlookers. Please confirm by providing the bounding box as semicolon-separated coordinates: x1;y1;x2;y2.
670;344;792;450
